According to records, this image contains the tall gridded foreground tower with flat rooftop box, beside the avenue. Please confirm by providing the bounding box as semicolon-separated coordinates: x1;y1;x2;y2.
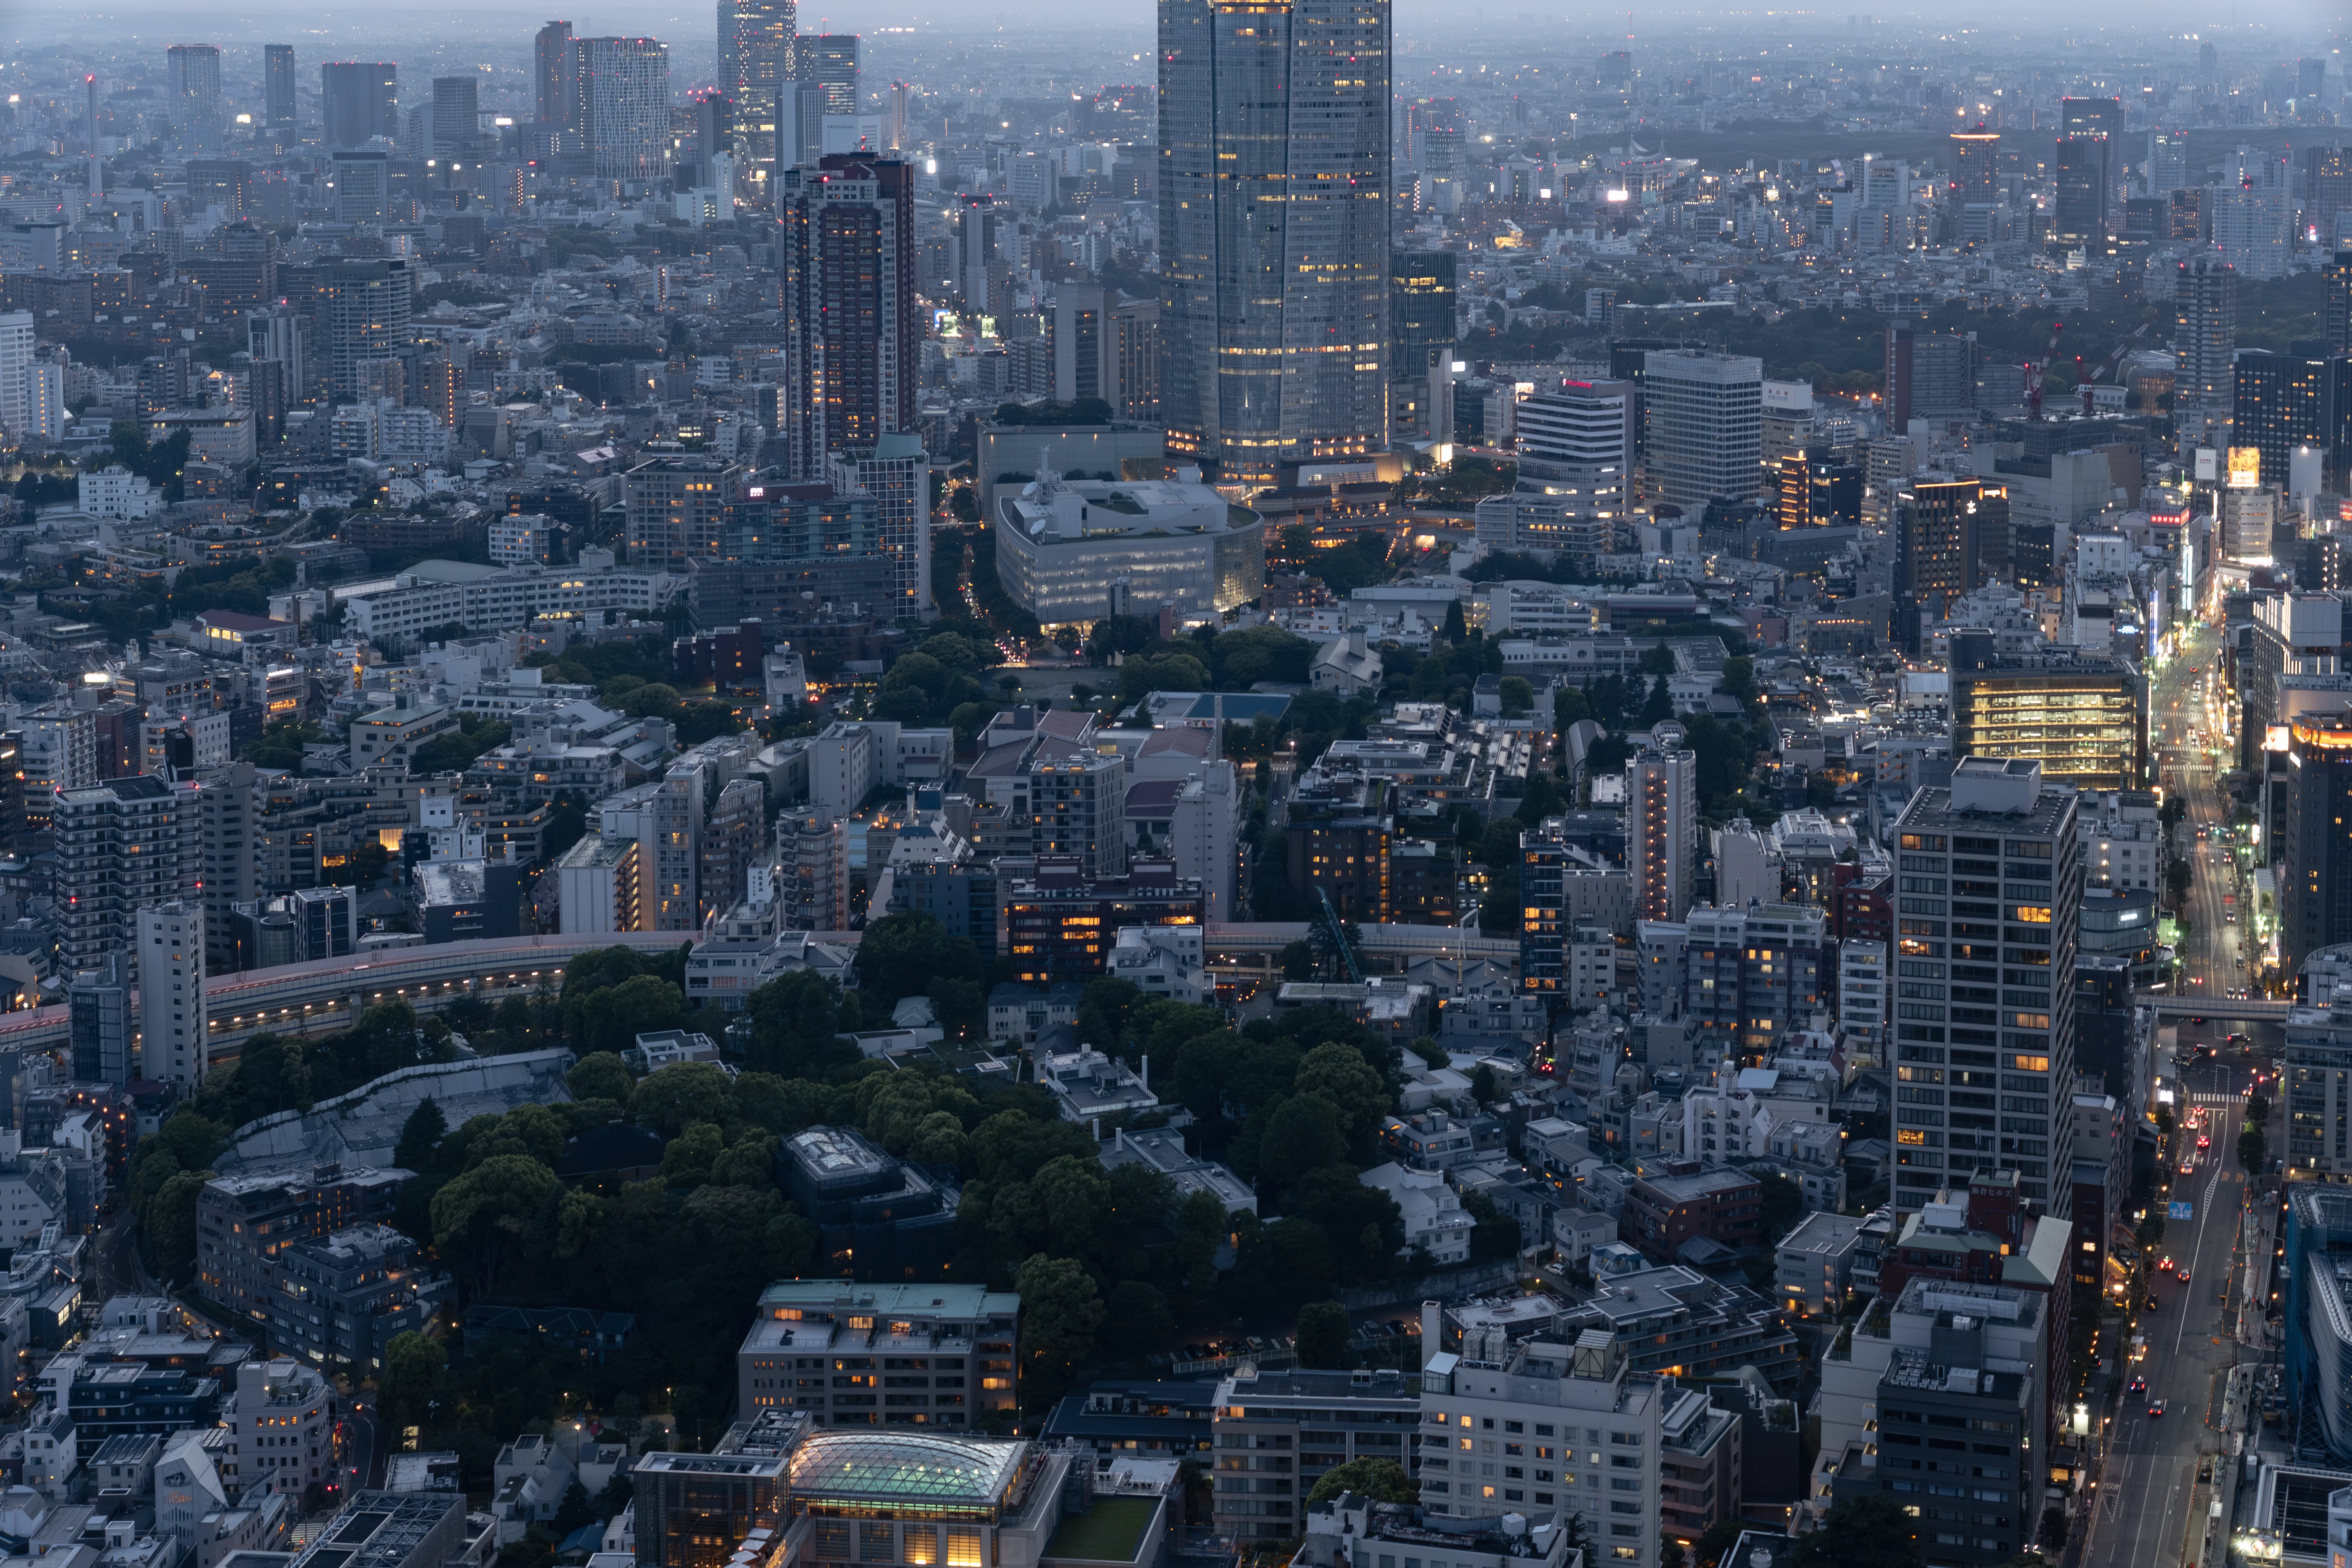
1893;762;2082;1218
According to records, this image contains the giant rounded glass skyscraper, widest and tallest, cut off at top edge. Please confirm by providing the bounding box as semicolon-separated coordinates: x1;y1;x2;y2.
1160;0;1392;484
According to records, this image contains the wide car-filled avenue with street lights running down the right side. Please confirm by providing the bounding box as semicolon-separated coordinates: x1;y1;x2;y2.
2082;625;2277;1568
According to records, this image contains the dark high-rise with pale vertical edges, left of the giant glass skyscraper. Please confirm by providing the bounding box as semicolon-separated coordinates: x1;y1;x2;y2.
776;153;922;479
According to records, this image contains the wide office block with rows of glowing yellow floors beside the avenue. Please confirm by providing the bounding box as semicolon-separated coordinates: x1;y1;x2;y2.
1950;632;2147;790
